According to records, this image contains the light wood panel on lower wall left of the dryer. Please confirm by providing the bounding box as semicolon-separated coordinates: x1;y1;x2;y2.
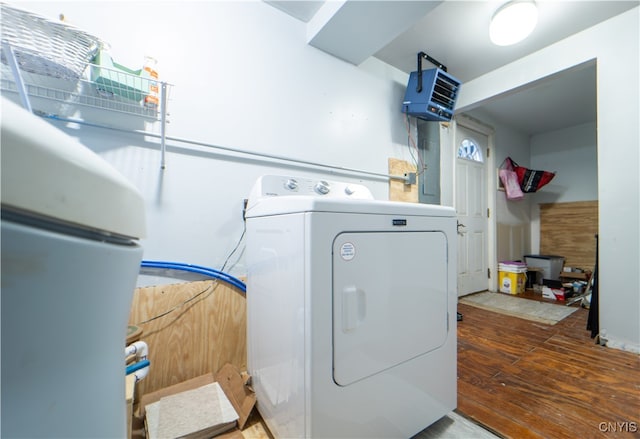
129;280;247;395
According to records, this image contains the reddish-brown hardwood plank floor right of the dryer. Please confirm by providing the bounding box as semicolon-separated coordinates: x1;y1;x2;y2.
457;299;640;439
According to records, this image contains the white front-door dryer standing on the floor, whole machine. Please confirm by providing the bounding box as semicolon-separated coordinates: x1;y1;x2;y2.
245;176;457;438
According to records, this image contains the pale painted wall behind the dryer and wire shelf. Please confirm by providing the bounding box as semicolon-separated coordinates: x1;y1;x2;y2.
13;1;420;275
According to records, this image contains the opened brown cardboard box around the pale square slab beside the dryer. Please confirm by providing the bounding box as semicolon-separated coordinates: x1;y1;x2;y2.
137;363;256;439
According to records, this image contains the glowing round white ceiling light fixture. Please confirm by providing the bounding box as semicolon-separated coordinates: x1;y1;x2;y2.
489;0;538;46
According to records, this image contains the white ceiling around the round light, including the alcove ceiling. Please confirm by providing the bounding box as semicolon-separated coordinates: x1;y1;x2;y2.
265;0;640;135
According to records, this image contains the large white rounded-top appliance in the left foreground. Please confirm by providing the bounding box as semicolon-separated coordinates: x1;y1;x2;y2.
1;99;145;438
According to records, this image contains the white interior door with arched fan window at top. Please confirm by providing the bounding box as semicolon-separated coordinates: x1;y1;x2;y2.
454;124;489;296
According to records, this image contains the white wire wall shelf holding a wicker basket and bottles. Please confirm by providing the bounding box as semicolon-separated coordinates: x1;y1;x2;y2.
0;4;170;120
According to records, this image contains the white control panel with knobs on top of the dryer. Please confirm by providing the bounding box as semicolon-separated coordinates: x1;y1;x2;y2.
249;175;373;200
